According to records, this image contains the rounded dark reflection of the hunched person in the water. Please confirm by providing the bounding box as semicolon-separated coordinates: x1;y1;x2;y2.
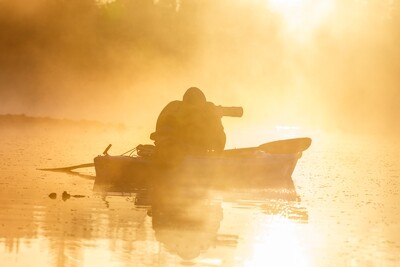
148;185;223;260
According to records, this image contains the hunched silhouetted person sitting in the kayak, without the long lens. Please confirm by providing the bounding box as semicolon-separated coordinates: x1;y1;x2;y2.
150;87;226;160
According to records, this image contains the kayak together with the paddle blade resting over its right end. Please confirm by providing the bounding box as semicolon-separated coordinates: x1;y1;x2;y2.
93;138;311;192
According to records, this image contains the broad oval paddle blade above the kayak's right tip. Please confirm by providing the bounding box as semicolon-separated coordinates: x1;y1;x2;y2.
258;137;311;154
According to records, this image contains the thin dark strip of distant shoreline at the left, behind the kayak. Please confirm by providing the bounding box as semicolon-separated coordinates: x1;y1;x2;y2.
0;114;126;130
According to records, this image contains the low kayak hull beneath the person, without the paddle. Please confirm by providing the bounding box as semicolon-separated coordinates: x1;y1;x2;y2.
94;153;301;192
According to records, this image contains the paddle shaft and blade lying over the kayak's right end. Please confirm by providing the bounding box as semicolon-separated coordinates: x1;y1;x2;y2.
224;137;311;155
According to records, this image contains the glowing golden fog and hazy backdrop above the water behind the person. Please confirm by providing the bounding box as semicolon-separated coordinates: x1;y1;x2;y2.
0;0;400;138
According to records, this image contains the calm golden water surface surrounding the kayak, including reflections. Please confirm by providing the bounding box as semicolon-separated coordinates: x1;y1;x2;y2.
0;129;400;267
